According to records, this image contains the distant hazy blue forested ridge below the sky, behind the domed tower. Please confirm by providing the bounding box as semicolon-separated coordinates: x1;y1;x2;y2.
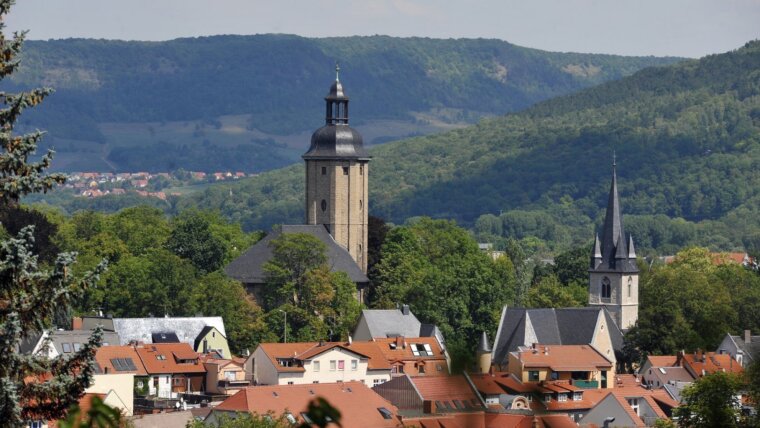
4;35;678;172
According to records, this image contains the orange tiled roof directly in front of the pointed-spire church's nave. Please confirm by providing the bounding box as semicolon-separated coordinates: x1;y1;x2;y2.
512;344;613;372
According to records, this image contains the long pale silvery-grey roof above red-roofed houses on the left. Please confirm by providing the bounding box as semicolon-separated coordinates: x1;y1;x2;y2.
113;317;227;346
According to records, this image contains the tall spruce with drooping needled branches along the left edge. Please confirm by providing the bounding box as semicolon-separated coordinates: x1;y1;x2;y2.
0;0;107;426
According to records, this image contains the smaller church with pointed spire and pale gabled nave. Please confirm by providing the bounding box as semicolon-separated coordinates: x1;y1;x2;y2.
491;162;639;369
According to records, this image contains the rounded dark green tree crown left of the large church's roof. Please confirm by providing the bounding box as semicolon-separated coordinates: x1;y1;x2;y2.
166;212;226;273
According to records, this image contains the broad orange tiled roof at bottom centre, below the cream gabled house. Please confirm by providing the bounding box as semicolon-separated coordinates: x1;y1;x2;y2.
213;382;399;428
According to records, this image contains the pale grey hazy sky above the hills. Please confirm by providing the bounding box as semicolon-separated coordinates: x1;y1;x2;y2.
6;0;760;57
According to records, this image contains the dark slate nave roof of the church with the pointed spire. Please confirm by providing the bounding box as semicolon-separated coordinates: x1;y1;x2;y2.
493;307;623;364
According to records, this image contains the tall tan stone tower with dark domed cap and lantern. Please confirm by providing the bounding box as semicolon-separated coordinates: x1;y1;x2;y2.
302;65;370;273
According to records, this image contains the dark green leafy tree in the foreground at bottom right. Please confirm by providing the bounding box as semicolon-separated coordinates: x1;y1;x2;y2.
673;372;742;428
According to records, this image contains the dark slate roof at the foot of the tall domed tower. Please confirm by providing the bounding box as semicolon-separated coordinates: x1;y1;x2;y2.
224;224;369;284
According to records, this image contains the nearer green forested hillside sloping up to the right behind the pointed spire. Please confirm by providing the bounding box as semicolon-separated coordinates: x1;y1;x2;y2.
179;41;760;251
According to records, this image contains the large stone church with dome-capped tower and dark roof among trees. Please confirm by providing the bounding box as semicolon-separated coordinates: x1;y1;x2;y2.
225;66;370;302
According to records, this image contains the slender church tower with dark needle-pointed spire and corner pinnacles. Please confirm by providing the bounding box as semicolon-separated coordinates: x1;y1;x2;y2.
588;162;639;331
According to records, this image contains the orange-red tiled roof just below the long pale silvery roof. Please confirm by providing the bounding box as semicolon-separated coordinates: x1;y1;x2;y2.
135;343;206;374
